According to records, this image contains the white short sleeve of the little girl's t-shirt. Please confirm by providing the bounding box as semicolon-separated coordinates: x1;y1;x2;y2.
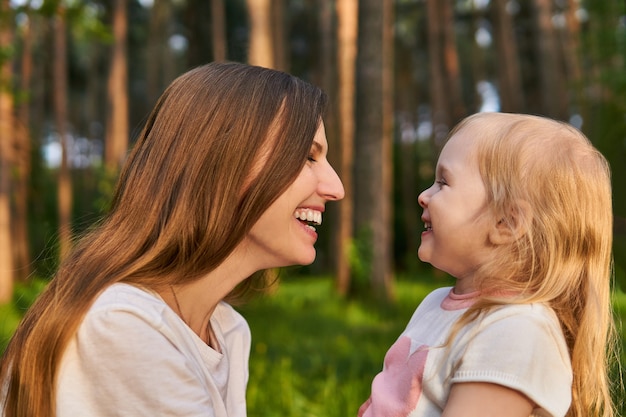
451;305;572;416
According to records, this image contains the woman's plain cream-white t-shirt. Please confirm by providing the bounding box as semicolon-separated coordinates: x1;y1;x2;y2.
56;284;250;417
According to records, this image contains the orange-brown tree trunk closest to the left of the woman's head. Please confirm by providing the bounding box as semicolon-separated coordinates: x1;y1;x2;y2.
105;0;128;172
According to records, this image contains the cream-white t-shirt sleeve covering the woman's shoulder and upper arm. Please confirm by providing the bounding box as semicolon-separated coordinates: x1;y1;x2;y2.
57;309;219;417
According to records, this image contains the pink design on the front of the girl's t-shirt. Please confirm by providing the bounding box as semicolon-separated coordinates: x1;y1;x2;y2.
358;337;428;417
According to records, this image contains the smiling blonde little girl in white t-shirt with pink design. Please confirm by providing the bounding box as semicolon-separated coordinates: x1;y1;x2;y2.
358;113;614;417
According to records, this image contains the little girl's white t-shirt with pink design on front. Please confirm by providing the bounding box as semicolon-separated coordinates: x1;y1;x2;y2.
358;288;572;417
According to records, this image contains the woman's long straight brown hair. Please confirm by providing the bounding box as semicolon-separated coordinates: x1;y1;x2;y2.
0;63;326;417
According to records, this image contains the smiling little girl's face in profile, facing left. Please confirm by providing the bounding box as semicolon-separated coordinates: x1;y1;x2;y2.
418;126;493;293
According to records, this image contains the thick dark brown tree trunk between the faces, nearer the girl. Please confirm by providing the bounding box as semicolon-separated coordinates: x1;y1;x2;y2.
355;0;393;300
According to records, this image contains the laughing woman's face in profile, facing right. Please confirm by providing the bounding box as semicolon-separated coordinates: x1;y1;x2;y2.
245;123;344;269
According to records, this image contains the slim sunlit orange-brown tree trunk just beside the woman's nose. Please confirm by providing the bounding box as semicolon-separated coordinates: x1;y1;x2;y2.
336;0;359;295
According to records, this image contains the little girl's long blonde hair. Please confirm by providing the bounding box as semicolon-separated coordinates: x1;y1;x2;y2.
450;113;616;417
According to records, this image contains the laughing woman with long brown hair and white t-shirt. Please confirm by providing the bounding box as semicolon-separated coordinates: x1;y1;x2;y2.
1;63;344;417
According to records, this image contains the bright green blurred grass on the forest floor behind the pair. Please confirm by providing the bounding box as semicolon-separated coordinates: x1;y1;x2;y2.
0;274;626;417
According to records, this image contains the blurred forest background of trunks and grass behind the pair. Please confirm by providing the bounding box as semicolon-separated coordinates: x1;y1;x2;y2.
0;0;626;416
